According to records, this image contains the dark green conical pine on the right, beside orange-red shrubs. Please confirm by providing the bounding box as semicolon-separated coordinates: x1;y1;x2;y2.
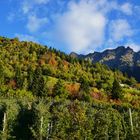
111;79;122;99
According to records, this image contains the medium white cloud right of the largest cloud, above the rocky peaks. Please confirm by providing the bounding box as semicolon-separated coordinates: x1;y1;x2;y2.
109;19;134;42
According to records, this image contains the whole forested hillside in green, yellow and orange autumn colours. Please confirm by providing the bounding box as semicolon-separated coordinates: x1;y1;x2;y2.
0;37;140;140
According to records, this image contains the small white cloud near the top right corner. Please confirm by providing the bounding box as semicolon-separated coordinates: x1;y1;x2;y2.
120;3;133;15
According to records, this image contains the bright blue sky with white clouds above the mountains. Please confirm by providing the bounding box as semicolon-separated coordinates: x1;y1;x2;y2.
0;0;140;54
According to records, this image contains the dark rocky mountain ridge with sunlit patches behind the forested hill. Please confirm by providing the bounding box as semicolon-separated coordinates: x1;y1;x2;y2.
73;46;140;81
